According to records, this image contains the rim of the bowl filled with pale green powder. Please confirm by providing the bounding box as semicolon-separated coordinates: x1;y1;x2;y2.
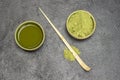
66;10;96;40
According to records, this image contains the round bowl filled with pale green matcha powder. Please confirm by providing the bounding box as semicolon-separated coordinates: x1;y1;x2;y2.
66;10;96;39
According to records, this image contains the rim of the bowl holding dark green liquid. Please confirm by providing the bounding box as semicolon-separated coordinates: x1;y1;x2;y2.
14;20;45;51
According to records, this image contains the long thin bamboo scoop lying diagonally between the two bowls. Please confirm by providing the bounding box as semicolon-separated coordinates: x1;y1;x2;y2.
39;8;91;71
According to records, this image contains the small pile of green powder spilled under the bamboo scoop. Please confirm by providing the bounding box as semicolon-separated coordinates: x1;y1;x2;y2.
64;46;80;61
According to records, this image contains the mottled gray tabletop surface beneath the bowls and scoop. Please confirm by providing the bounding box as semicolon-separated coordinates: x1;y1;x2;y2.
0;0;120;80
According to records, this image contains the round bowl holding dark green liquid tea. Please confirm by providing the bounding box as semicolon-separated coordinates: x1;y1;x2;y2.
15;21;45;51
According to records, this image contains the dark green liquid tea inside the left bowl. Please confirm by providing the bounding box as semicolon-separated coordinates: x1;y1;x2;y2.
17;23;43;49
